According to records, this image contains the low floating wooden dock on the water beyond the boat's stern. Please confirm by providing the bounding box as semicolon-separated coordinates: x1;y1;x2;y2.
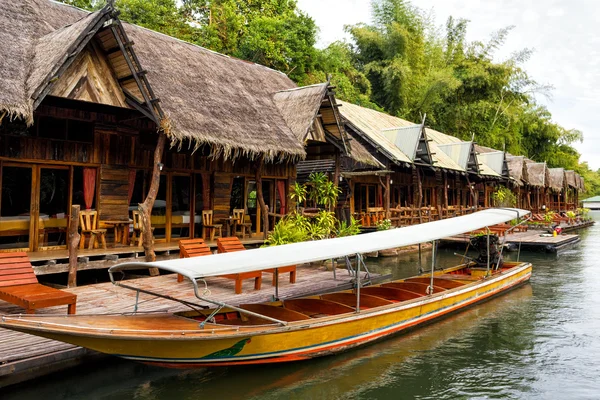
441;230;580;253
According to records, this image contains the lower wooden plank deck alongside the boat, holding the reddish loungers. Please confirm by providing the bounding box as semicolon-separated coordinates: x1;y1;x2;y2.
0;266;377;388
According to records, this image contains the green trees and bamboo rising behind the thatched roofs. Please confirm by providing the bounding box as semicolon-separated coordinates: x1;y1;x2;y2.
64;0;600;196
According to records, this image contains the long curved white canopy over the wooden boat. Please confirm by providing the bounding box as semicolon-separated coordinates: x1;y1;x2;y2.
109;208;530;280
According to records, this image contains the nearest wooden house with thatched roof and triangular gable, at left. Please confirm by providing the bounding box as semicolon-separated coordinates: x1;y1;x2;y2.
0;0;347;251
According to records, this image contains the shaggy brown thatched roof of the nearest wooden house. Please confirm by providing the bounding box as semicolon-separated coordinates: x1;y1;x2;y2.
0;0;314;159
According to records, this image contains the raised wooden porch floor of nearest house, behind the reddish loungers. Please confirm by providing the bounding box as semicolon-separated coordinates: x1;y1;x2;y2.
27;238;264;275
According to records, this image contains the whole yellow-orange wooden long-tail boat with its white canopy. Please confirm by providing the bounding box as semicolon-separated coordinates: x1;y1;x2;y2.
0;209;532;368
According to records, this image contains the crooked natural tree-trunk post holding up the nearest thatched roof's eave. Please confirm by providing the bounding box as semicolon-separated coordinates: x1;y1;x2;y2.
139;132;166;276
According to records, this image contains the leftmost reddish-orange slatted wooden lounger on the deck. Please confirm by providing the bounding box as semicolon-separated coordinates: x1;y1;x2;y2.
0;252;77;314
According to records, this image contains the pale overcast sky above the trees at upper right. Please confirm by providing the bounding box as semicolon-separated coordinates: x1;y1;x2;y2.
298;0;600;169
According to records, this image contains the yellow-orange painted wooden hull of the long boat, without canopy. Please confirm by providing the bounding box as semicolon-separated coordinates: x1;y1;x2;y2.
0;264;531;368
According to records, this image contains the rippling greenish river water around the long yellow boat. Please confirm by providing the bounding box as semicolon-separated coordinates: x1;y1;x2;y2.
0;214;600;400
